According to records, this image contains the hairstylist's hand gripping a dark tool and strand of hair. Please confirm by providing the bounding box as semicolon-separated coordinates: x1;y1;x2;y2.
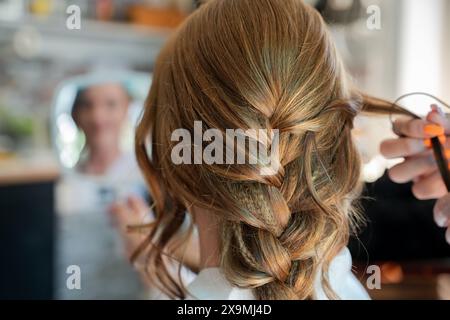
381;106;450;200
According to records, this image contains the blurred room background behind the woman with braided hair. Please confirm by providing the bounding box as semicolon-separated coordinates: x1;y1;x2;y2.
0;0;450;299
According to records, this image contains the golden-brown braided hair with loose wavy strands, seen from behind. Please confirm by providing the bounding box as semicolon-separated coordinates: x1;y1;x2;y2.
135;0;408;299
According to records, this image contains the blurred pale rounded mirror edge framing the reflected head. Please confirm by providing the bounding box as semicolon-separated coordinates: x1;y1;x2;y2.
51;72;151;169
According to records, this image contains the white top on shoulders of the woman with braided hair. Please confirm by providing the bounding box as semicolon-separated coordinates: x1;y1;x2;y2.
187;248;370;300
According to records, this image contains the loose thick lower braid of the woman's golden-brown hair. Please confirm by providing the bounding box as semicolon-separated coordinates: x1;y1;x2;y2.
222;103;354;299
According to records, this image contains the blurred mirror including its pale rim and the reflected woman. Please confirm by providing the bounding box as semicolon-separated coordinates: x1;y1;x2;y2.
52;72;150;299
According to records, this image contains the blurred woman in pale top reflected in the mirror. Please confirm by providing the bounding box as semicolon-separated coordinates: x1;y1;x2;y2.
56;82;148;299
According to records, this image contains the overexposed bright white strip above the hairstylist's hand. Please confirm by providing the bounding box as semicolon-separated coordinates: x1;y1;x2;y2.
398;0;450;114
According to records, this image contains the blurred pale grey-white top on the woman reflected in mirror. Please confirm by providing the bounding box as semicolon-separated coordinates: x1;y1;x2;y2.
55;154;146;300
